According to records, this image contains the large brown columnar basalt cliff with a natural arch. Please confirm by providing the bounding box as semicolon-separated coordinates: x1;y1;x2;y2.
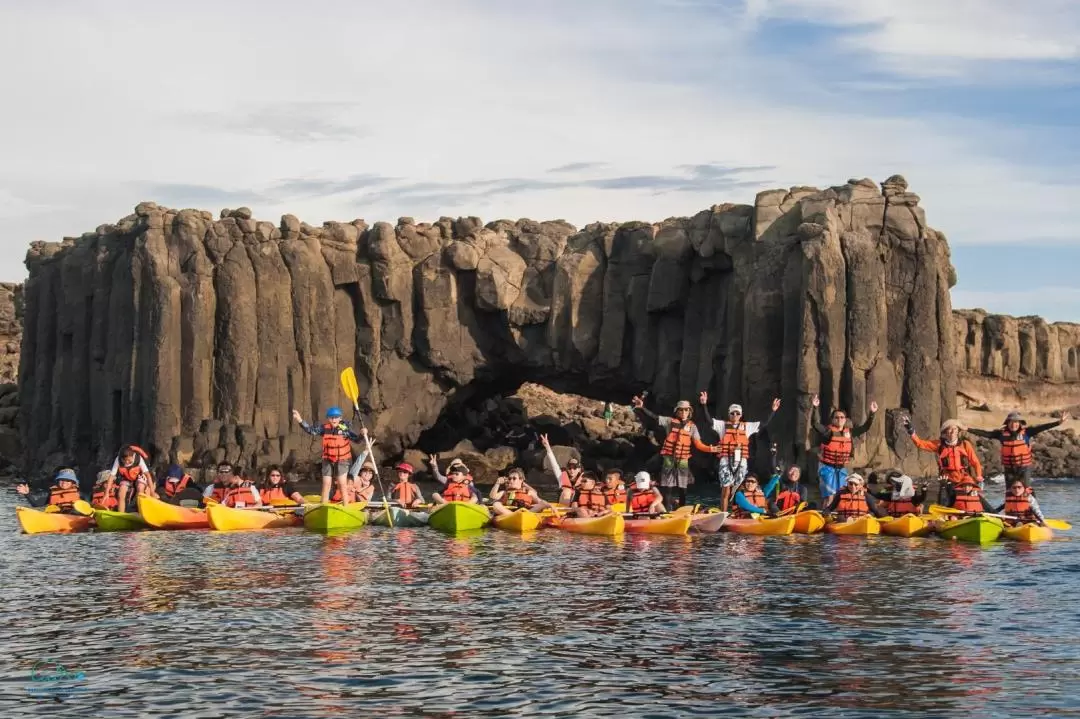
19;176;956;472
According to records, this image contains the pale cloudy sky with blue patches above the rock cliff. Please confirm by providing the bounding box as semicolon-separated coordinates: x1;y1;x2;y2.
0;0;1080;322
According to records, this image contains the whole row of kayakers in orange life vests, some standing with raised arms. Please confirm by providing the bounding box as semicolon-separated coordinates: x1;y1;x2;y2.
8;374;1068;533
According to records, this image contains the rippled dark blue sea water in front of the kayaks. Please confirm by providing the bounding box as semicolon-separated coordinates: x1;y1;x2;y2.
0;483;1080;719
